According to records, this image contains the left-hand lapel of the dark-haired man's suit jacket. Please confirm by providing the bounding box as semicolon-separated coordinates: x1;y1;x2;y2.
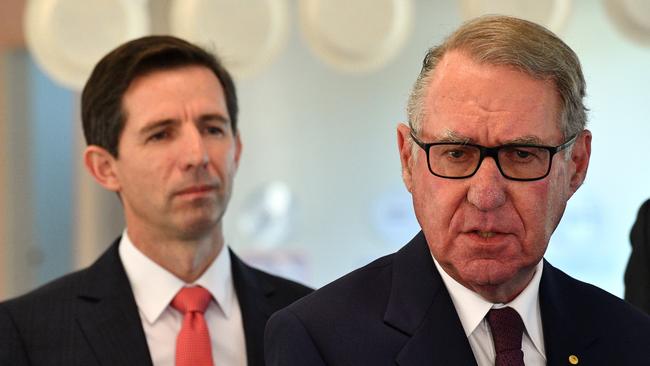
76;239;152;365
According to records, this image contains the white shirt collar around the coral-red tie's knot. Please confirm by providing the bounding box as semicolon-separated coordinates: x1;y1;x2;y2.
119;229;234;324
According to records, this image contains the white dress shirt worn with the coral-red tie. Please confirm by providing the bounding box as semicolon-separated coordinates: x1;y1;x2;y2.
119;230;246;366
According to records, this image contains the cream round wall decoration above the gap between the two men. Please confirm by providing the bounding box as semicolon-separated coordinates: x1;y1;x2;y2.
300;0;413;72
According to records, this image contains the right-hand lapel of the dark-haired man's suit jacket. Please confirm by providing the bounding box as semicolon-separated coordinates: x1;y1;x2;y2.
230;251;275;366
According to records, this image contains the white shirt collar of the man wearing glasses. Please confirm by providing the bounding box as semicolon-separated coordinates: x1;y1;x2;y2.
431;255;546;354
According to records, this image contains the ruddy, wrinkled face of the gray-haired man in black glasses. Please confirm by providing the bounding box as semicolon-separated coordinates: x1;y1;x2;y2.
400;51;588;300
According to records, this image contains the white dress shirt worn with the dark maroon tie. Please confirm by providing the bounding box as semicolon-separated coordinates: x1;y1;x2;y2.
432;255;546;366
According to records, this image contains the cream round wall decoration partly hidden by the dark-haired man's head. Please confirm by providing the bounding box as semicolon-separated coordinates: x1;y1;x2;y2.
169;0;289;77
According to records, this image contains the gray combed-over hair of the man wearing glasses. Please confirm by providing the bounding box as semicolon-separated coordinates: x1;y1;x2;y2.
407;15;587;138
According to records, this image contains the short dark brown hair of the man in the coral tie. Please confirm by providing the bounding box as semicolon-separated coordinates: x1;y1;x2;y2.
81;36;238;157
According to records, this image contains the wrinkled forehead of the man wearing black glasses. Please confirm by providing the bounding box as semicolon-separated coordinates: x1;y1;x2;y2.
422;52;562;143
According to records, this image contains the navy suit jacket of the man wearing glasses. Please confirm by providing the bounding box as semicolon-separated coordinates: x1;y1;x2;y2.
265;233;650;366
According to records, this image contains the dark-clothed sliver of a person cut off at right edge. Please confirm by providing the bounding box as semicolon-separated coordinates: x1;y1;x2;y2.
625;200;650;314
